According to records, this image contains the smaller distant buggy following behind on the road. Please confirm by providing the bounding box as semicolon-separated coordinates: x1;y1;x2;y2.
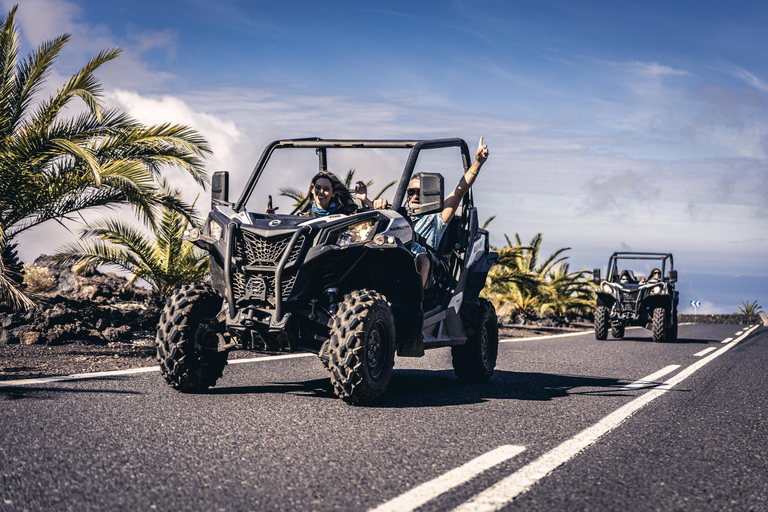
592;252;680;342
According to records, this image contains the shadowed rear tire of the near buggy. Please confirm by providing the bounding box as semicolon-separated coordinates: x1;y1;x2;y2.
451;299;499;383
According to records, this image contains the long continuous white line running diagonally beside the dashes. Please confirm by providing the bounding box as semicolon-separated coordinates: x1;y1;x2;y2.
453;326;757;512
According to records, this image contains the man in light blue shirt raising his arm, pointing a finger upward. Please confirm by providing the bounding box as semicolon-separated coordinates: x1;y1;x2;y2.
373;137;488;288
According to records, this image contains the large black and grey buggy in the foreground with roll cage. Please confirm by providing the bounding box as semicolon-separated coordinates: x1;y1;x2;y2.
156;138;498;404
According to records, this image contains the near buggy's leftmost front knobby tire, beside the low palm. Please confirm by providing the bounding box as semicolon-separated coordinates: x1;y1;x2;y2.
155;284;227;393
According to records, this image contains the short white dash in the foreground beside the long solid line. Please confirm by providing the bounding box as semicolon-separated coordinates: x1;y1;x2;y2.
369;445;525;512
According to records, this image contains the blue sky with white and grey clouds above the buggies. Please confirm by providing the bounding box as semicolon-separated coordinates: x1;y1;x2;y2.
7;0;768;313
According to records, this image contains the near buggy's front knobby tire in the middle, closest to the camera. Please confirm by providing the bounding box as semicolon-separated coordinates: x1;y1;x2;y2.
328;290;396;405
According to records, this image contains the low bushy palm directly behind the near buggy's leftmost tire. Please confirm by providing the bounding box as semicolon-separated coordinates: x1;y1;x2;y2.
56;184;208;299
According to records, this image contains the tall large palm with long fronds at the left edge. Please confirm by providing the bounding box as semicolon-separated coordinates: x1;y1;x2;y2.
0;6;210;308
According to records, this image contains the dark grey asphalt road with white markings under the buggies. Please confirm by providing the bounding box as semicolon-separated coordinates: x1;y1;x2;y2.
0;325;768;512
